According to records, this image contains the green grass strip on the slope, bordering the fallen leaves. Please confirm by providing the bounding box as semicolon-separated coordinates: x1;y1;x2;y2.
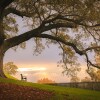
0;78;100;100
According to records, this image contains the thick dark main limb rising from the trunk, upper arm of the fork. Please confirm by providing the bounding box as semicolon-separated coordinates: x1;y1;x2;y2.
4;23;75;50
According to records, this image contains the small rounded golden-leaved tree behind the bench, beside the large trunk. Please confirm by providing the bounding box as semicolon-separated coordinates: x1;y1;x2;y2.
4;62;18;75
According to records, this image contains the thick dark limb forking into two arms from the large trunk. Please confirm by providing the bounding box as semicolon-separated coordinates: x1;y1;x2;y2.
4;23;82;55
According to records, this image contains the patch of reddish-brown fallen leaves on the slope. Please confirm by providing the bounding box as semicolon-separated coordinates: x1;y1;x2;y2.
0;83;55;100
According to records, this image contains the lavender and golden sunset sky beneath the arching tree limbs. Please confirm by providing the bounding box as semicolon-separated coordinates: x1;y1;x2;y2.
4;18;86;82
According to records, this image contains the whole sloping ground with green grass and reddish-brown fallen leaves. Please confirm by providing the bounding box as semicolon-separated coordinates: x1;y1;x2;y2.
0;78;100;100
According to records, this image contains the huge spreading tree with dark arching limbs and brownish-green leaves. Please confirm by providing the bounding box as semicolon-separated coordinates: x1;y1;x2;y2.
0;0;100;77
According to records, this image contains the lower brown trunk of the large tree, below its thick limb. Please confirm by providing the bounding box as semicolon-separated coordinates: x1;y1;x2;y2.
0;47;7;78
